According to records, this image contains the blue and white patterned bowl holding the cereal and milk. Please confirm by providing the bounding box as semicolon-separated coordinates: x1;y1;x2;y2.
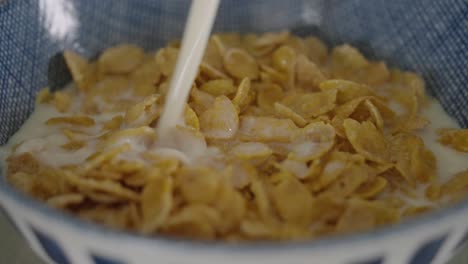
0;0;468;264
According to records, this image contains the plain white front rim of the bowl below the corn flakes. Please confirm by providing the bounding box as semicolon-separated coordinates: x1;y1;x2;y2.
0;167;468;252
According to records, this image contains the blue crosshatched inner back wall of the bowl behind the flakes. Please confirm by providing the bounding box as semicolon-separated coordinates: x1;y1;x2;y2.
0;0;468;144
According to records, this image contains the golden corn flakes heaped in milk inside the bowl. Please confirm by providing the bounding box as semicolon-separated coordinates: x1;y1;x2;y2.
4;32;468;241
